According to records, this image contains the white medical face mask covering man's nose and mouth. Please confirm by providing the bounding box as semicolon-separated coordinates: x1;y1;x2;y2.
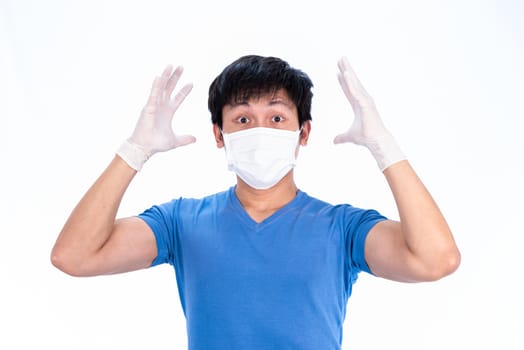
222;128;300;190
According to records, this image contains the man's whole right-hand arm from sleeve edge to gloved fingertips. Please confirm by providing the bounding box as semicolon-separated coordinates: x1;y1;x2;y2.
334;58;460;282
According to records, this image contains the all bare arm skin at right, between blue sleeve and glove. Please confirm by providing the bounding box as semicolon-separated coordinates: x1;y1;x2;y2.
365;160;460;282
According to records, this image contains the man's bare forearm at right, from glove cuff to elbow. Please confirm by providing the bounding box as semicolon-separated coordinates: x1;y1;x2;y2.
384;161;460;275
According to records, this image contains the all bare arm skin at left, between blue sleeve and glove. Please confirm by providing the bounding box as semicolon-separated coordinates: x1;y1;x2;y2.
51;156;157;276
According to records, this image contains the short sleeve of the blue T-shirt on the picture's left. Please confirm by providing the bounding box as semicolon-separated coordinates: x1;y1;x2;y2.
138;201;176;267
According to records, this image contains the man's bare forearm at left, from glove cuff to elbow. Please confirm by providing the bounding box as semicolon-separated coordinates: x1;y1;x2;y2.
52;156;136;270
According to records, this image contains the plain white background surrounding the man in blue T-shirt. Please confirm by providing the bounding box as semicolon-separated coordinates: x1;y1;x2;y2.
0;0;524;349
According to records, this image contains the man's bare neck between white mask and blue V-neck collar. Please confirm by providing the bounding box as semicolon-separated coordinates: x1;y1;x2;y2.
235;171;298;222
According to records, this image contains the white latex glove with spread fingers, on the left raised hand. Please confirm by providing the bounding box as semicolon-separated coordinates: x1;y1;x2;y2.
117;65;196;171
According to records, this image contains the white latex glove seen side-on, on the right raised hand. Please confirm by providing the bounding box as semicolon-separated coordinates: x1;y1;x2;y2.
333;57;406;171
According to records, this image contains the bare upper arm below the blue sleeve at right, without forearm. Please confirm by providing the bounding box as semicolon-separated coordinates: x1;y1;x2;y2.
364;220;427;282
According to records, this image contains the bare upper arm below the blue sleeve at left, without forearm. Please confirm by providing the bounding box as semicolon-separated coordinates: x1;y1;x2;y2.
88;217;157;275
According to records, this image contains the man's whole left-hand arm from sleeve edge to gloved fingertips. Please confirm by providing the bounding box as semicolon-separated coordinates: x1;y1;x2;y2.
51;66;195;276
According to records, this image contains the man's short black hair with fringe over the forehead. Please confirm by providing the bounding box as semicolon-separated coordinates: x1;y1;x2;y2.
208;55;313;128
